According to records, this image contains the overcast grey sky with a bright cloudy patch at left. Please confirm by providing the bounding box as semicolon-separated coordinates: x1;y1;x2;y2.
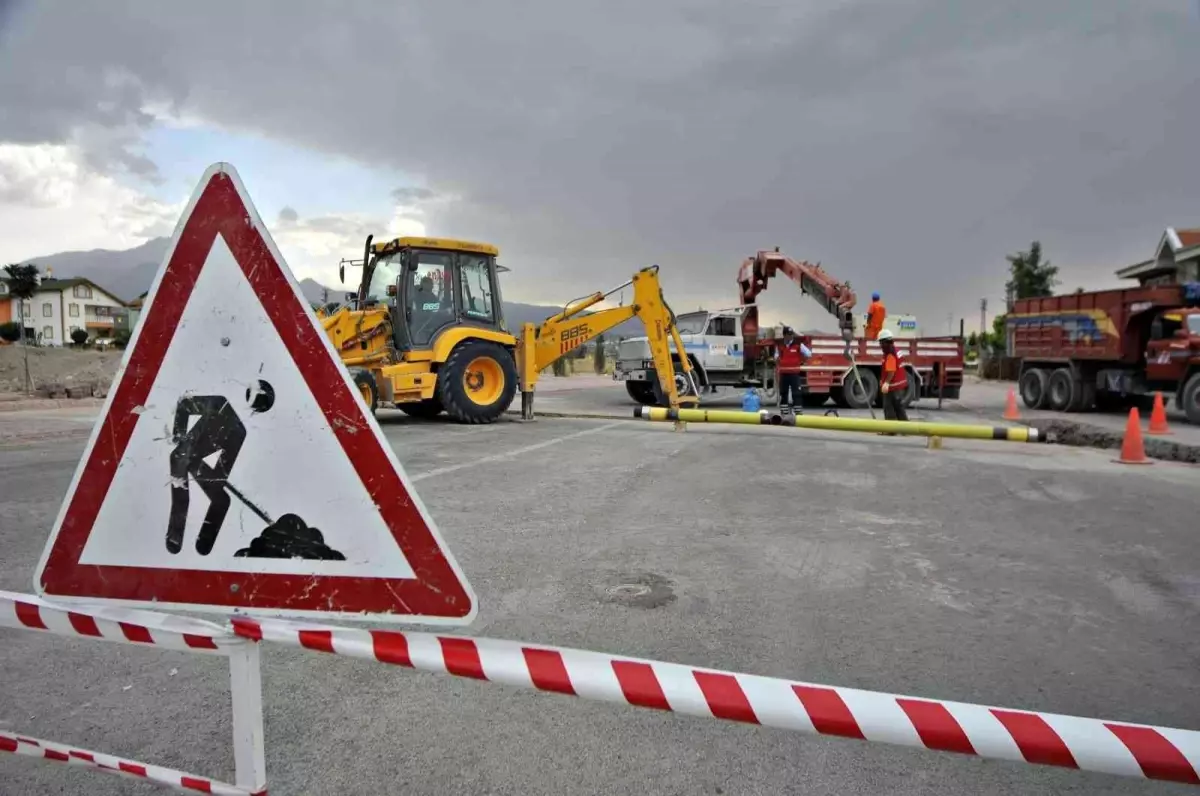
0;0;1200;331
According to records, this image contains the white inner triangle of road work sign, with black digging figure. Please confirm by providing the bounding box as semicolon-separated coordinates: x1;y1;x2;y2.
79;235;413;577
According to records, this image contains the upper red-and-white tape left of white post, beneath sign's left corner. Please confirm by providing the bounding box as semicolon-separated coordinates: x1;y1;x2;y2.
0;592;238;656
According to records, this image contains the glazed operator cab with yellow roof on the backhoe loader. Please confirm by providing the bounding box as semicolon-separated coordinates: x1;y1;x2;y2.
359;238;508;352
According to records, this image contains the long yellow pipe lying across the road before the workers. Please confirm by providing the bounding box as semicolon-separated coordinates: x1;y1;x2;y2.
634;406;1046;442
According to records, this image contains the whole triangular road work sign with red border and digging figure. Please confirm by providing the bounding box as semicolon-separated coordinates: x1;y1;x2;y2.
34;163;475;624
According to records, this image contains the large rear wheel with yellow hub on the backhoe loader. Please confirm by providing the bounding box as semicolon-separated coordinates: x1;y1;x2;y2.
438;340;517;424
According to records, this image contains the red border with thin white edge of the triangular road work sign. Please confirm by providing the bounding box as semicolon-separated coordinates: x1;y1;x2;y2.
34;163;478;626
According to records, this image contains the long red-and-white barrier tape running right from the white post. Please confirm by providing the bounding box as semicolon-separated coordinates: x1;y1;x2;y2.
233;617;1200;785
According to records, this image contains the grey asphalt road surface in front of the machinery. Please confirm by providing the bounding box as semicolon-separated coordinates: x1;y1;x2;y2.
0;408;1200;796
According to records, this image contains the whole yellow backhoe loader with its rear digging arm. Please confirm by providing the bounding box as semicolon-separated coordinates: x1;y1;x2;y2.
318;237;698;424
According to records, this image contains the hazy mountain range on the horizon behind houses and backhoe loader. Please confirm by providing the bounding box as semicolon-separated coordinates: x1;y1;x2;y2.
26;238;646;337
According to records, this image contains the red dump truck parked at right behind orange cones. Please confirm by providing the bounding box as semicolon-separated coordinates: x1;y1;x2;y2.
1006;282;1200;425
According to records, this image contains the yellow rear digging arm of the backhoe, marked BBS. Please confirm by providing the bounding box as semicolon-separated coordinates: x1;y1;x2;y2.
517;265;700;420
